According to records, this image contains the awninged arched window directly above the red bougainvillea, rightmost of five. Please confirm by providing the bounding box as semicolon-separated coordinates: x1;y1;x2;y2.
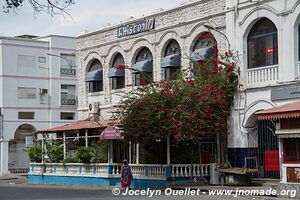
191;32;217;61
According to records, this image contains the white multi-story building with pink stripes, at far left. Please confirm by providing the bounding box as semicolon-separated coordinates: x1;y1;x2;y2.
0;35;77;174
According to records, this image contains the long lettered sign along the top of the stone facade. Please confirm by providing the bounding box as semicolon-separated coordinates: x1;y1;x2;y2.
117;18;154;38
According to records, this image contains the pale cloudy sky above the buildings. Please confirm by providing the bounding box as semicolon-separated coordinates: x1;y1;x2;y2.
0;0;184;37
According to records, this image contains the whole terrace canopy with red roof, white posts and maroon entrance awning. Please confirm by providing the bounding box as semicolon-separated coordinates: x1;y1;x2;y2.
35;120;123;160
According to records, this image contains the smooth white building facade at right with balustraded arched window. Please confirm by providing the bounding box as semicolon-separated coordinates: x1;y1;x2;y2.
226;0;300;179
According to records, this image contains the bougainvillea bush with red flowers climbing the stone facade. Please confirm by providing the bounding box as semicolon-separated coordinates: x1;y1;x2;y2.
114;47;238;143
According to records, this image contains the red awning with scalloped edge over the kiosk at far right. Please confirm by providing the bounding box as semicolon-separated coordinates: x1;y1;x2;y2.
255;102;300;120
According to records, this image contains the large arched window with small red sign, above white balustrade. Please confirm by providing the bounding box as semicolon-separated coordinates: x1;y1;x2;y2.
247;18;278;69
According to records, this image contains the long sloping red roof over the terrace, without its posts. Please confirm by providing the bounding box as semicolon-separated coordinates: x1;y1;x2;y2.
36;120;109;133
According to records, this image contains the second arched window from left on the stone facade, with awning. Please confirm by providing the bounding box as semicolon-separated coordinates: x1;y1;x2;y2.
108;53;125;90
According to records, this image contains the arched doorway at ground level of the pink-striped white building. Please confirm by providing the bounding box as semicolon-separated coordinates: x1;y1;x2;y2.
8;124;36;172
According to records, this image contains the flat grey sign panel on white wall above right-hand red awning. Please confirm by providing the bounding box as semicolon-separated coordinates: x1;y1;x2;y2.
271;87;300;101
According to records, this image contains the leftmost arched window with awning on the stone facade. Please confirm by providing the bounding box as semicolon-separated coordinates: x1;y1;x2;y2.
85;59;103;92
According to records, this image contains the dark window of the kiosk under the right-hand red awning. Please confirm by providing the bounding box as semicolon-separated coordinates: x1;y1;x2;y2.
283;138;300;162
